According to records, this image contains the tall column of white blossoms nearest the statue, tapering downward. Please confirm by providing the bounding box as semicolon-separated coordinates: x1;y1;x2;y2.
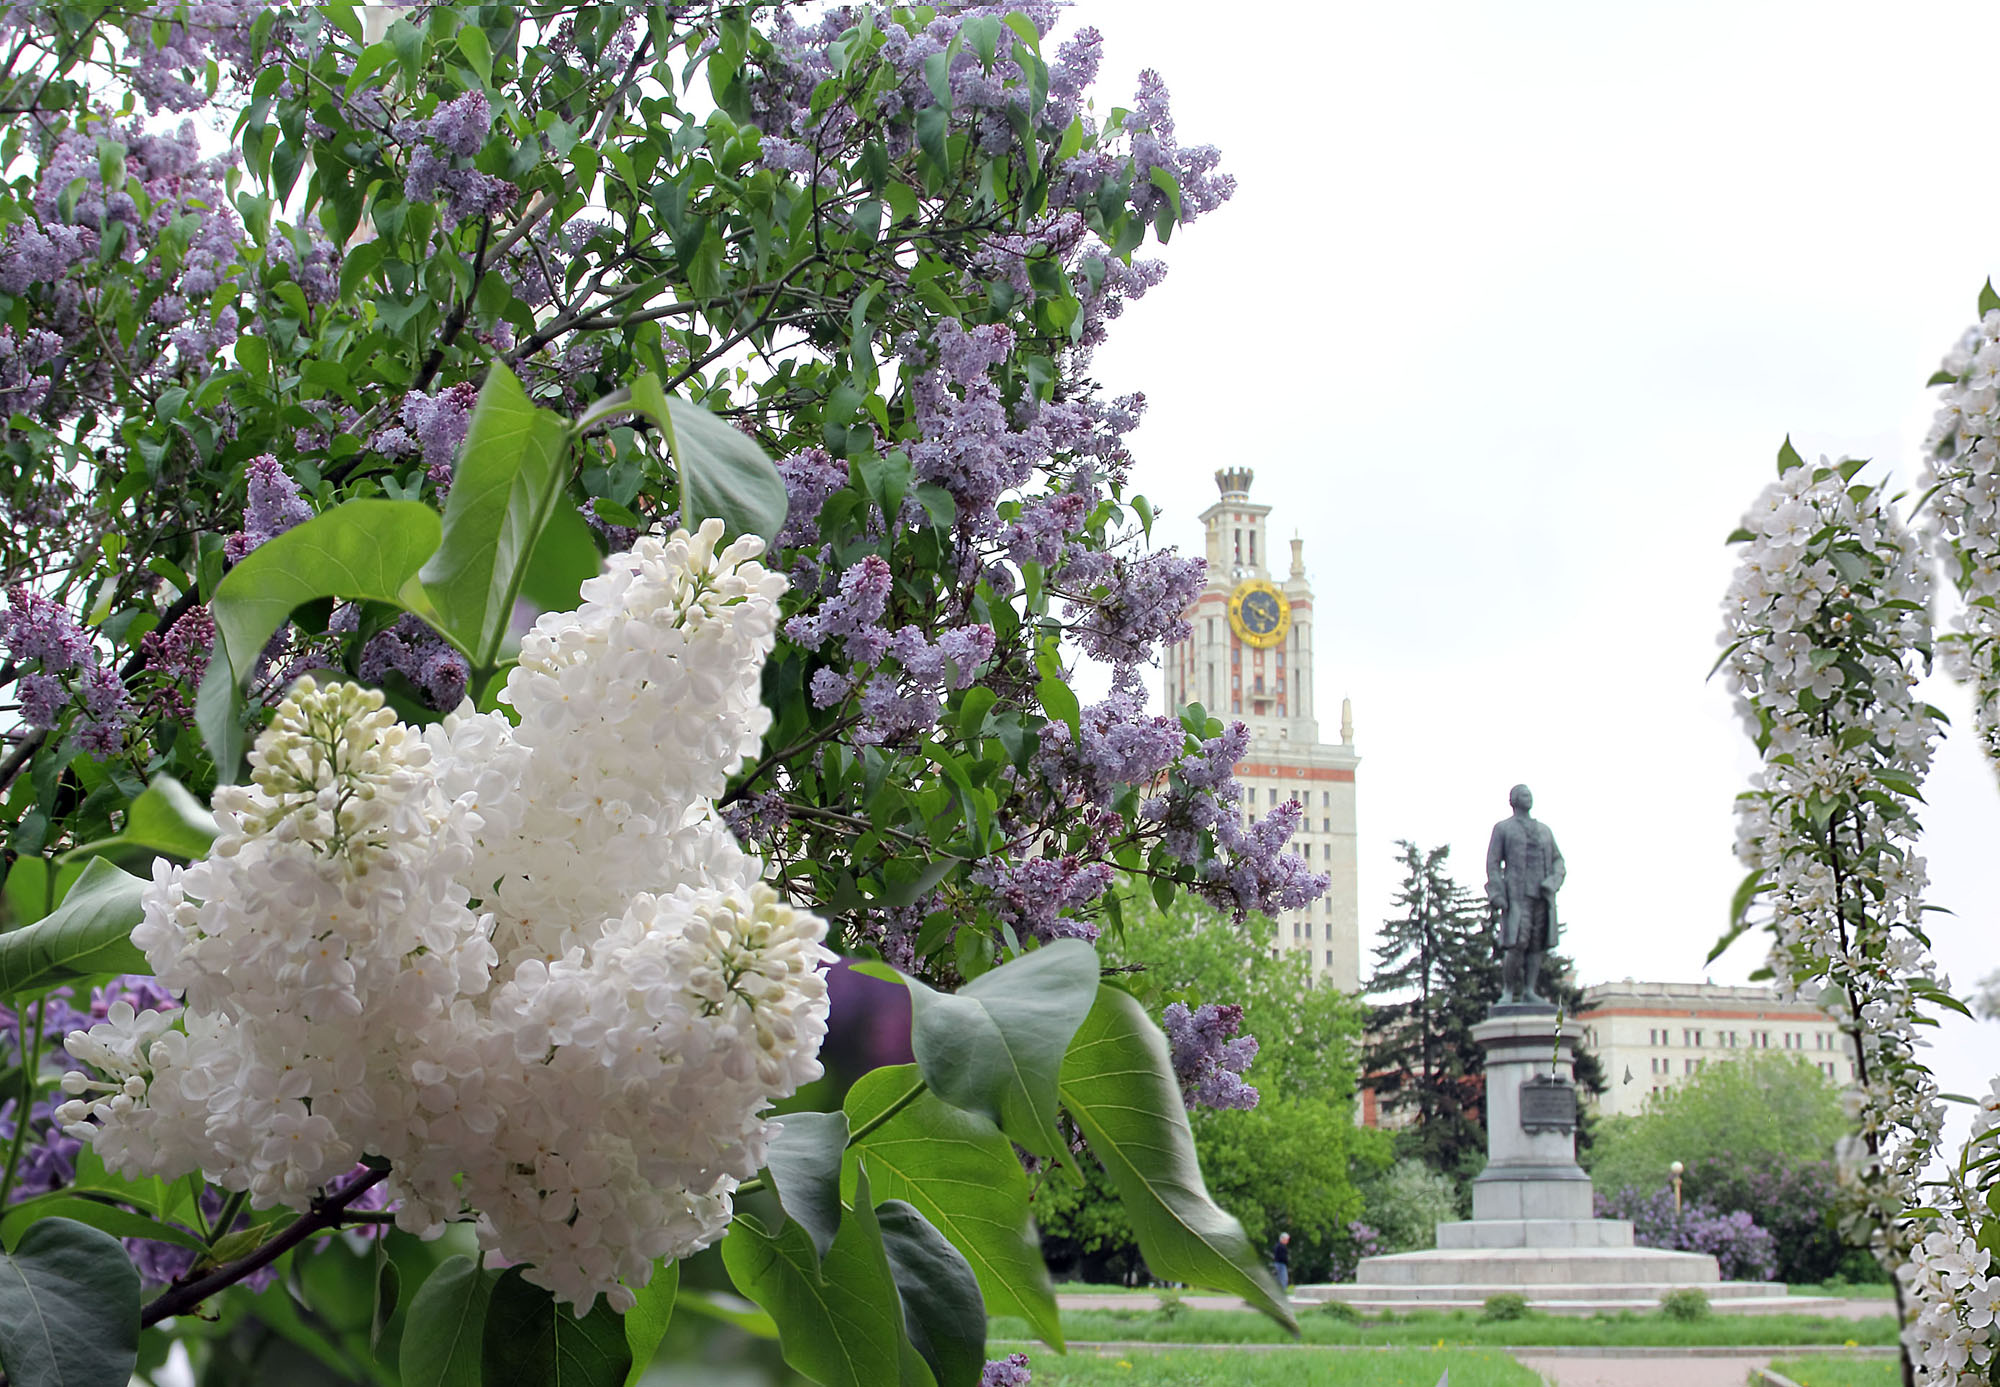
1722;462;1944;1303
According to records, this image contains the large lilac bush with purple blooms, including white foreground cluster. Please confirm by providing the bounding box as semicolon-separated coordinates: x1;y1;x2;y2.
0;0;1324;1387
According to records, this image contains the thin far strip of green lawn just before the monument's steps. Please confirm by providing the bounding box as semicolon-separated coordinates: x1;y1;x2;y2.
988;1305;1896;1351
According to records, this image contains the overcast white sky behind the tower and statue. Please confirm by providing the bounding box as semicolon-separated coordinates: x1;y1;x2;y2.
1068;0;2000;1091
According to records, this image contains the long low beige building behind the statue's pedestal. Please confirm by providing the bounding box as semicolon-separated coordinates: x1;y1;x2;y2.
1578;977;1854;1115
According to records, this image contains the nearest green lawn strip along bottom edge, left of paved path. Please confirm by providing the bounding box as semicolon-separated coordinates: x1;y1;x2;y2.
986;1341;1542;1387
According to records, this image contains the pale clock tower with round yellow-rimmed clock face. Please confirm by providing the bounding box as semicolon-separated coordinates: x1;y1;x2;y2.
1166;468;1362;991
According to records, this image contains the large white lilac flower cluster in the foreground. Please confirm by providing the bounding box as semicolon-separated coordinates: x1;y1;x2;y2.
60;522;832;1309
